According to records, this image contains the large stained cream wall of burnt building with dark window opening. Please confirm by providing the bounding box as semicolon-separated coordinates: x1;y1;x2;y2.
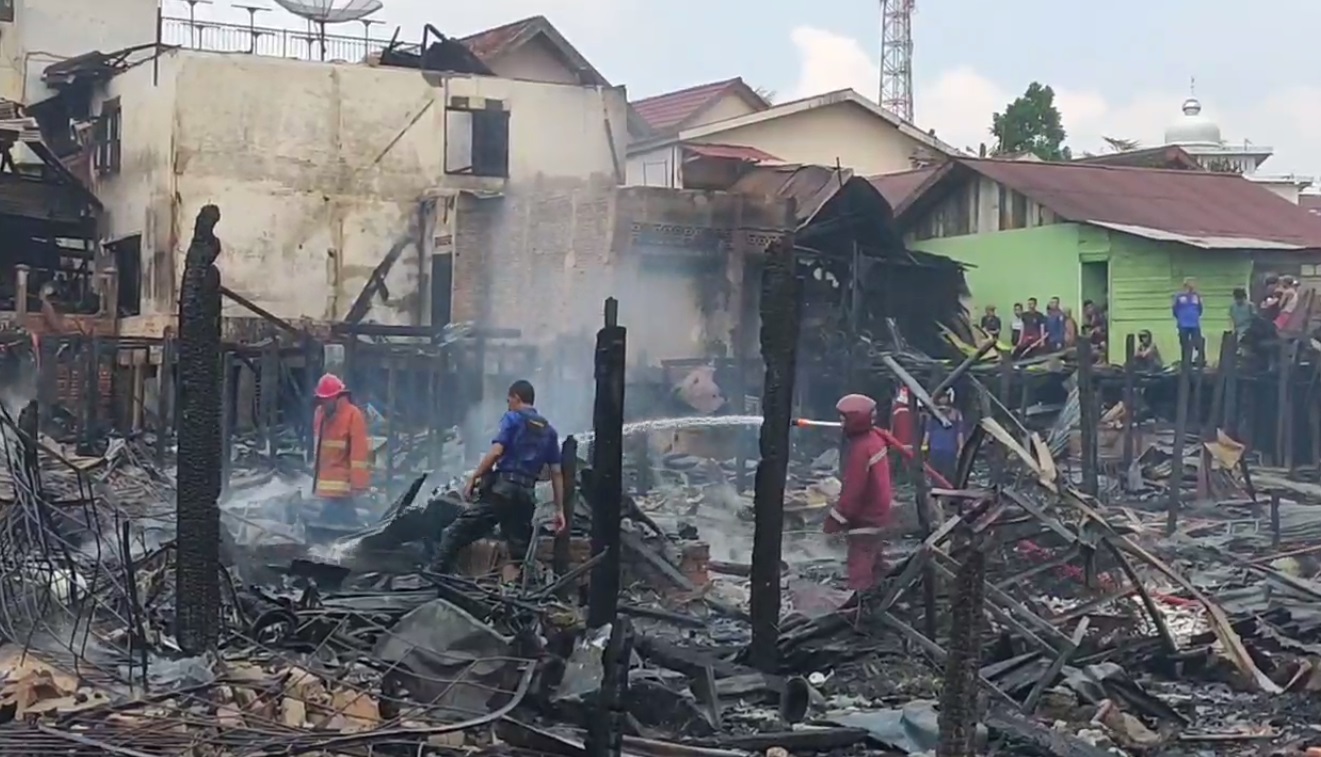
103;52;626;328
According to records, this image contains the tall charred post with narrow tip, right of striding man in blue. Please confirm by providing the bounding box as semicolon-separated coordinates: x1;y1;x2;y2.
587;297;627;628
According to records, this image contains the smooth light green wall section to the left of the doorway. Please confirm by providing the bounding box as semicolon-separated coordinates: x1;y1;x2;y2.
910;223;1083;315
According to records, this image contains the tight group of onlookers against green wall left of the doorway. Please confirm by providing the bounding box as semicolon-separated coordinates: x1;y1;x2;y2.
980;297;1108;358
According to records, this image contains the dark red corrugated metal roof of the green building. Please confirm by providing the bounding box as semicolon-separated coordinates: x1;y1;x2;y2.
958;160;1321;248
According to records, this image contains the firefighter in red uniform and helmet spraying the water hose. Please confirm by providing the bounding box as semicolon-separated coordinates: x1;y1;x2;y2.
826;394;893;591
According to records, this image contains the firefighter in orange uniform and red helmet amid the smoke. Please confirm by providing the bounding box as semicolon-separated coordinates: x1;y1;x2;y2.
312;374;371;526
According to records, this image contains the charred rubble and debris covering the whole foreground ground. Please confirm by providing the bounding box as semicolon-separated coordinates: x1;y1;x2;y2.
10;372;1321;757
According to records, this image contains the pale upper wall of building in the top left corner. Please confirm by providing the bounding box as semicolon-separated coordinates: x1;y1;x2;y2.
0;0;159;103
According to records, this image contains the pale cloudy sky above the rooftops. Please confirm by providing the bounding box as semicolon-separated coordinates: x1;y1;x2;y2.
173;0;1321;177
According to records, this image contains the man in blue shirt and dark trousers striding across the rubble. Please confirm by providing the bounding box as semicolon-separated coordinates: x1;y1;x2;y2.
433;380;565;573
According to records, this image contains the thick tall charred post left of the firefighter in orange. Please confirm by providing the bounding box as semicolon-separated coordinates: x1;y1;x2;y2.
176;205;222;654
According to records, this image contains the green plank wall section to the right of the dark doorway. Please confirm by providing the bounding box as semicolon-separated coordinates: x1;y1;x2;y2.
1110;233;1252;362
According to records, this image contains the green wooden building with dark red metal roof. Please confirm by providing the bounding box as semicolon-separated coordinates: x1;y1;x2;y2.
872;160;1321;361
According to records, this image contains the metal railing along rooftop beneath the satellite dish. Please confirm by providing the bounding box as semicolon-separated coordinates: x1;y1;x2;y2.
161;16;390;63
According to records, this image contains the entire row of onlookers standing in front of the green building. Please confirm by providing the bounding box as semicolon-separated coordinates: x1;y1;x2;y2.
980;276;1301;370
